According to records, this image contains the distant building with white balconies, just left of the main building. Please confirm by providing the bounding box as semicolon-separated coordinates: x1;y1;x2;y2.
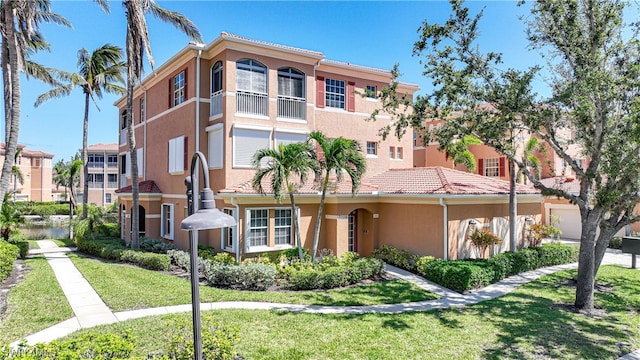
77;144;119;206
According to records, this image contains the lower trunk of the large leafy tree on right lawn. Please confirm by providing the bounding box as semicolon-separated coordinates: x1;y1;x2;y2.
575;209;600;311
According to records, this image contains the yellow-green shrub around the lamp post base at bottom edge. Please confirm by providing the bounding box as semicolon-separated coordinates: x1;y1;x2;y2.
165;315;239;360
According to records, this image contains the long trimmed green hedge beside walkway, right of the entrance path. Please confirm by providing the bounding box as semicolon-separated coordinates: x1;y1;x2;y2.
417;244;578;293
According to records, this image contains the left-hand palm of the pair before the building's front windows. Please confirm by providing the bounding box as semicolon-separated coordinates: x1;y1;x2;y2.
252;142;319;260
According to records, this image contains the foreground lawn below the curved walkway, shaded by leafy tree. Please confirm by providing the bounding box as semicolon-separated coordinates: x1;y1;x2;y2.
58;266;640;359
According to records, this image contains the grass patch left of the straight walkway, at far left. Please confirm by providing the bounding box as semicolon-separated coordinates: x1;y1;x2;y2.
0;257;73;343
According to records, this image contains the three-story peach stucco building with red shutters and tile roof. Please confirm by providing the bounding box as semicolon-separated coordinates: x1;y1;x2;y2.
115;33;542;258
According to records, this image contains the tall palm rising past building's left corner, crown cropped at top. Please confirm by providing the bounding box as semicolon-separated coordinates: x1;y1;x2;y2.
122;0;202;248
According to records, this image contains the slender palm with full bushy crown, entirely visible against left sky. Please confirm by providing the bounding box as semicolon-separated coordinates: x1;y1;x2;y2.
35;44;125;219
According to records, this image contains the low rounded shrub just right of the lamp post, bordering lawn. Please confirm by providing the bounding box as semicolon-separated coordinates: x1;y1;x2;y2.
203;261;276;290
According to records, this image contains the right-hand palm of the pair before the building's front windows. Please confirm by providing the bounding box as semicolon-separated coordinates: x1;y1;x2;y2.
309;130;367;260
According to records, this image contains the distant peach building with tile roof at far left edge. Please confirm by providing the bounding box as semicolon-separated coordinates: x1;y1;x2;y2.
0;143;54;201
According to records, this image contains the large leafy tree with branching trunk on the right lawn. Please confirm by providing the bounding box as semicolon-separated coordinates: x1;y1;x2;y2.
382;0;640;311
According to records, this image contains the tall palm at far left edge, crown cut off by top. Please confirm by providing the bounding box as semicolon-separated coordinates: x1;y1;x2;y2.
0;0;77;208
